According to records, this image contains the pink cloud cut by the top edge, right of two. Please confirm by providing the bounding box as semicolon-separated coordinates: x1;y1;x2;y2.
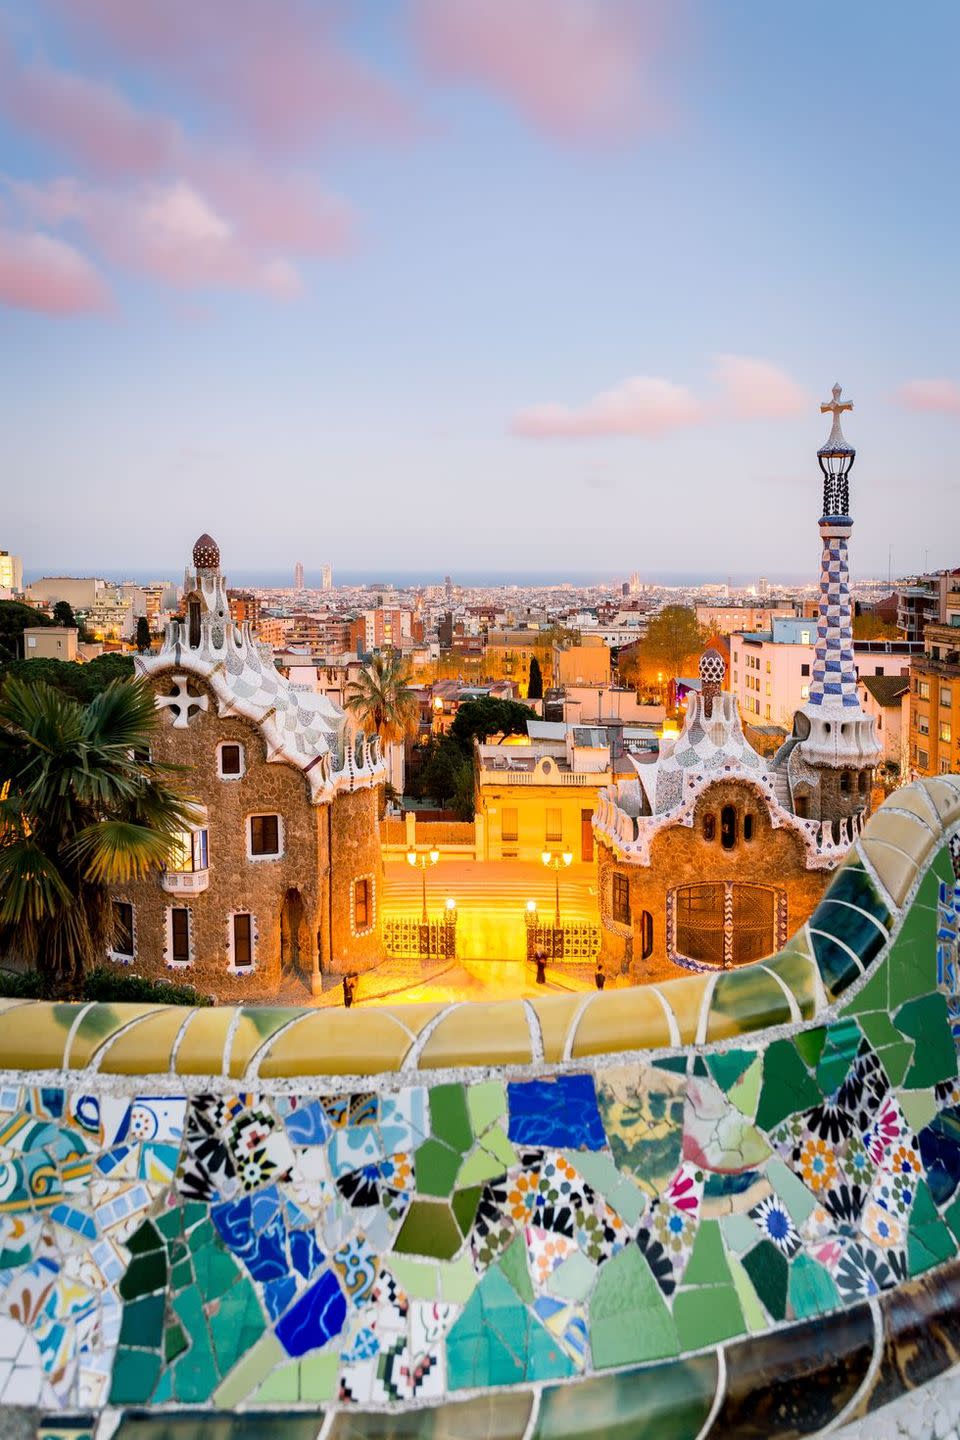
413;0;668;140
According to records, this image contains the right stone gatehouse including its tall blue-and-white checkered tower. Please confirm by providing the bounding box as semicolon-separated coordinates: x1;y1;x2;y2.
593;386;881;979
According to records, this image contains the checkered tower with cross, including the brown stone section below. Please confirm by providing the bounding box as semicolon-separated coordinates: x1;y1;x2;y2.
789;384;881;819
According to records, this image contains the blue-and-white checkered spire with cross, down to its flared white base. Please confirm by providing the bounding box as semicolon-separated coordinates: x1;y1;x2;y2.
800;384;879;769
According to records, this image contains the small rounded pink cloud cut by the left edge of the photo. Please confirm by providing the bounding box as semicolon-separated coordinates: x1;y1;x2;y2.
0;229;109;315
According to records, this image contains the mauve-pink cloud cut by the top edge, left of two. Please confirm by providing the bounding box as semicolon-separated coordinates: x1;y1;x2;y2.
48;0;416;150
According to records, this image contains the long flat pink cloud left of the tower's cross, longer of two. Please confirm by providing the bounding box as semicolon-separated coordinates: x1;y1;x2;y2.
511;374;702;438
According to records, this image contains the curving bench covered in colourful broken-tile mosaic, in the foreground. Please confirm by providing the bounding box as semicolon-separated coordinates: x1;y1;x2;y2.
0;776;960;1440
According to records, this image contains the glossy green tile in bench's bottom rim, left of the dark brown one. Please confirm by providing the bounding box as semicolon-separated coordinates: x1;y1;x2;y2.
532;1355;718;1440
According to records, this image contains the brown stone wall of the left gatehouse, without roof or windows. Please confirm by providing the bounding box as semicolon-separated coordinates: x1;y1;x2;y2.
115;674;381;999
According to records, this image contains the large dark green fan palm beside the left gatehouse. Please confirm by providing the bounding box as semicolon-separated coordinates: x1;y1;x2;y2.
0;678;191;994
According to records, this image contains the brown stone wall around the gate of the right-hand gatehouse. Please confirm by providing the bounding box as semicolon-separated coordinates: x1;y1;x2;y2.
597;780;829;981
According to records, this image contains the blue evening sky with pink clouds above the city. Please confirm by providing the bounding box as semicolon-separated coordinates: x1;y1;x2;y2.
0;0;960;579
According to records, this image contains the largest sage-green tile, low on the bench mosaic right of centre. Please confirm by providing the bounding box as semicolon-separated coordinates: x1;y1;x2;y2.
590;1246;679;1369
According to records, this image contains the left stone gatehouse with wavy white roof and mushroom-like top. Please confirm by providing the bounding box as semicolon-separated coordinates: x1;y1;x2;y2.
111;536;384;998
